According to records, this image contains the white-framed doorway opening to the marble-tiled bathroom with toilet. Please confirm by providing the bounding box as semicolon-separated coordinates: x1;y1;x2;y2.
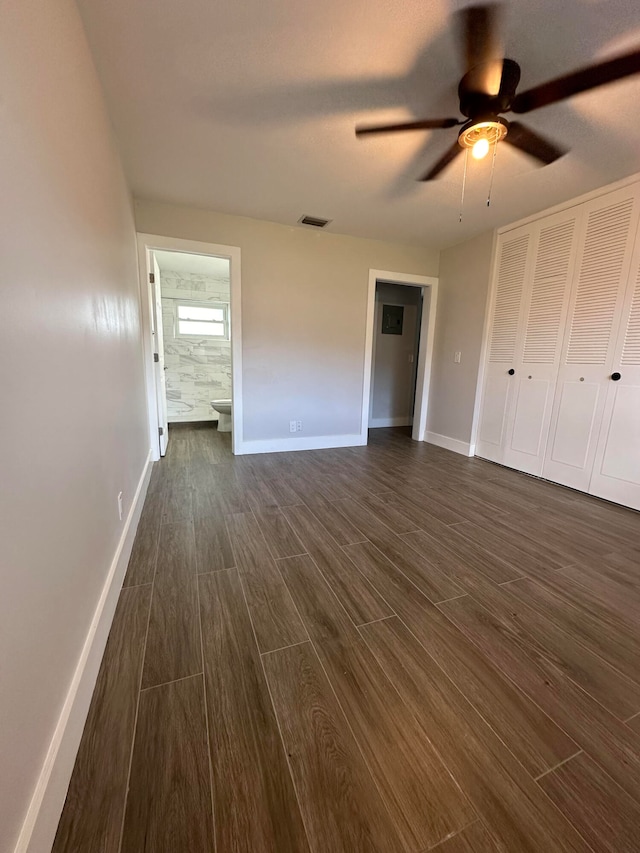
138;234;242;459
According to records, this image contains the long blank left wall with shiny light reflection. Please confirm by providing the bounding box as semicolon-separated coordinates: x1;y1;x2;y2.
0;0;149;853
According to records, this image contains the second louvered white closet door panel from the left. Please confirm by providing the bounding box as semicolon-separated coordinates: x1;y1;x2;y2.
503;208;579;475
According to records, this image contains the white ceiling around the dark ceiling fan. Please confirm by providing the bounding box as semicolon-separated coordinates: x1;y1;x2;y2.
78;0;640;247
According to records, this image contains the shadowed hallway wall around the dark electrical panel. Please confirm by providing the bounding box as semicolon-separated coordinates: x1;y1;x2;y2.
369;283;422;427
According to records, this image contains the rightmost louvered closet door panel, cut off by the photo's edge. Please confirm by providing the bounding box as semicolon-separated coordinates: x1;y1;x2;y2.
589;235;640;509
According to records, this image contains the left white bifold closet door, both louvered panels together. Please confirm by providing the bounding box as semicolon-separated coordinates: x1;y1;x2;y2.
477;206;577;475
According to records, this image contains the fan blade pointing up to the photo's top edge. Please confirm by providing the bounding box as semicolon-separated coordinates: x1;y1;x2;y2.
458;3;504;95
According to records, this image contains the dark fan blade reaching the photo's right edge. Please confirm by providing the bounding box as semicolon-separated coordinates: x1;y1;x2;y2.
511;50;640;113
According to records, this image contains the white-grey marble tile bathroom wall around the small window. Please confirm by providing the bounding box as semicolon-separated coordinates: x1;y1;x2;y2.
160;270;231;423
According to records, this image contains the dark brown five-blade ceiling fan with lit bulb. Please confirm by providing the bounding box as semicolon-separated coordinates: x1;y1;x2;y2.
356;3;640;181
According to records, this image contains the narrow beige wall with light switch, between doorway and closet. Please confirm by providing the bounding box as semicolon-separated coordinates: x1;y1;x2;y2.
427;231;493;442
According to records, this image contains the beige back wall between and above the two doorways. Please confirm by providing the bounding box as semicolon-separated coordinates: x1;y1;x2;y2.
136;201;438;441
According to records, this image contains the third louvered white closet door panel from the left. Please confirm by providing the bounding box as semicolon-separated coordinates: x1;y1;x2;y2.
542;187;638;491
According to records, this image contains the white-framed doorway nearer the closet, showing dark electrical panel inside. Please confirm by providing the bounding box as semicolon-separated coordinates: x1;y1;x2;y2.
361;270;438;444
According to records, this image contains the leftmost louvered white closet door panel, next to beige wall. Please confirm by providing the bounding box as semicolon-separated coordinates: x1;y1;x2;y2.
476;226;533;462
